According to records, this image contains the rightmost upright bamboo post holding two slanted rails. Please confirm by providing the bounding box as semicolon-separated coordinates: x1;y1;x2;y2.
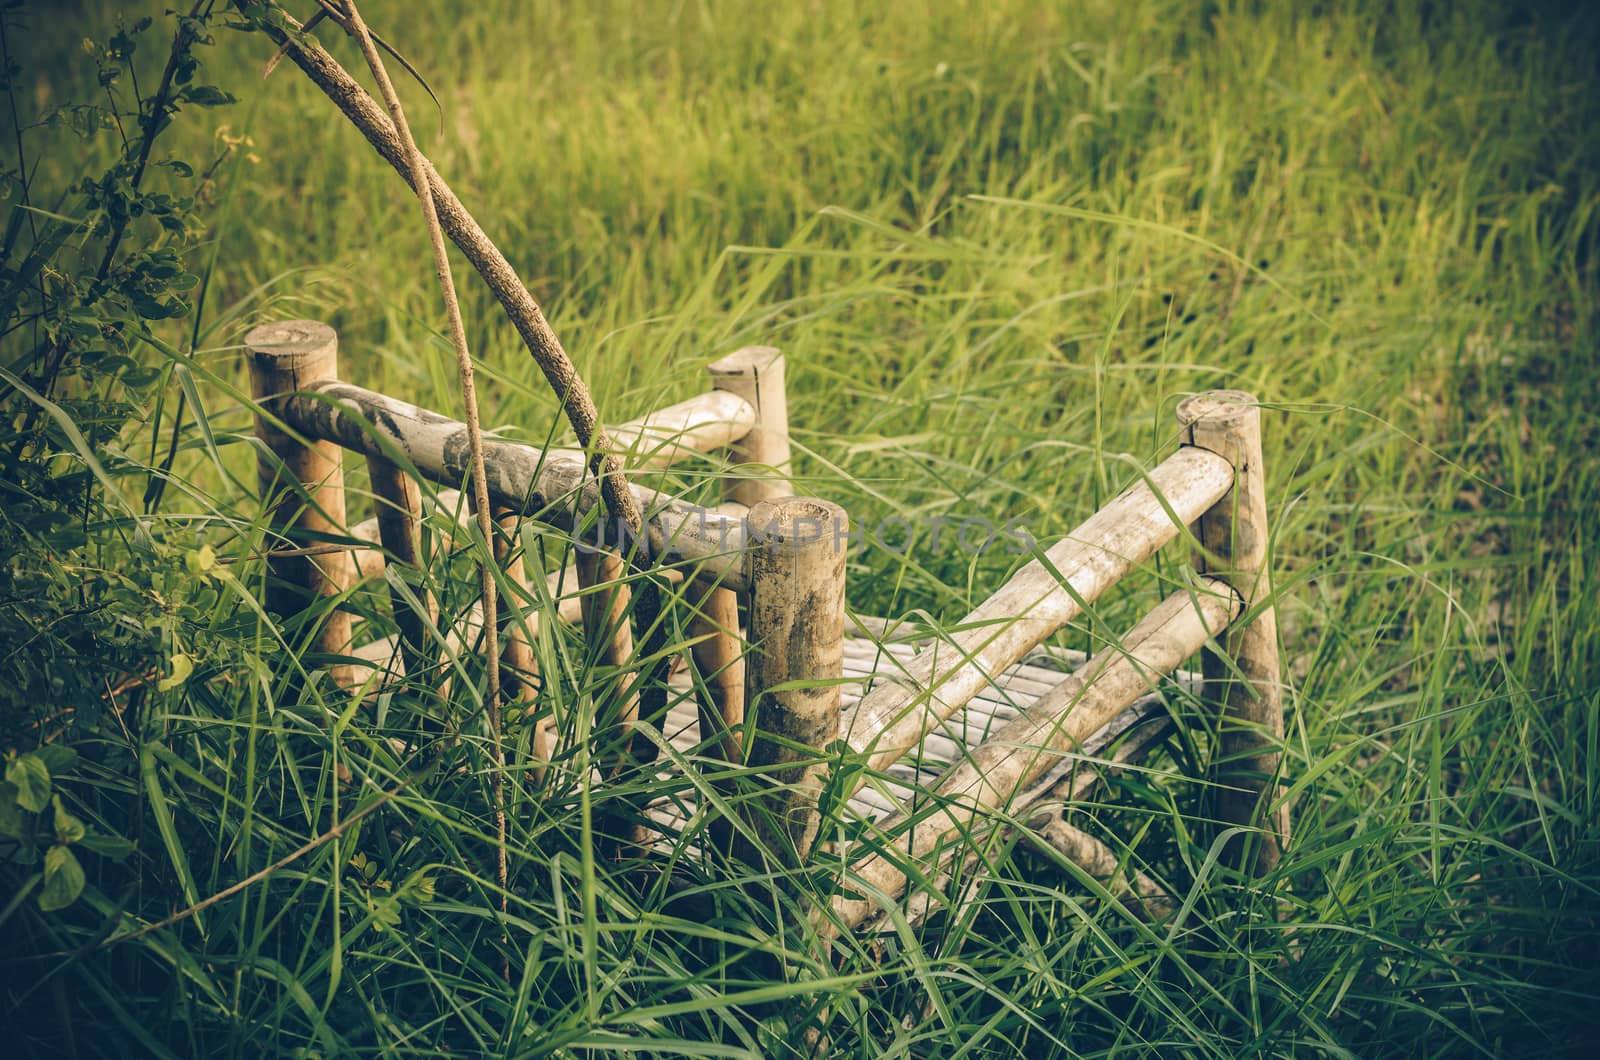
1178;391;1290;873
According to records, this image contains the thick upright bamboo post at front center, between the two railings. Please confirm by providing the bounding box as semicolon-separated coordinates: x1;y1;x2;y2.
744;496;848;866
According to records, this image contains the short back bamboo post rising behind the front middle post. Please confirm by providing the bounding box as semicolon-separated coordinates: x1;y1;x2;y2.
707;346;794;508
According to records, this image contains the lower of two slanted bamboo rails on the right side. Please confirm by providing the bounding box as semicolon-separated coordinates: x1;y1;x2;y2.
824;580;1240;930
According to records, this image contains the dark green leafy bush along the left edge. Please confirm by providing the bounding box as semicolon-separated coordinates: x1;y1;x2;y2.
0;3;234;930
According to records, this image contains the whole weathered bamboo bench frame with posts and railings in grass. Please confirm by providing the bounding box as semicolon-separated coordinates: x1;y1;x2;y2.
245;320;1290;934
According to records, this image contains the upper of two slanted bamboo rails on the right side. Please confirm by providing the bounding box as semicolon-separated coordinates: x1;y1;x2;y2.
845;448;1234;781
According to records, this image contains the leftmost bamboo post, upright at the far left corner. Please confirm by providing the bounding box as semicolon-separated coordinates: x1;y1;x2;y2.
245;320;355;687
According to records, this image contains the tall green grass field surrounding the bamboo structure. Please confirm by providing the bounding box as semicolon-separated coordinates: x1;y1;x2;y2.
0;0;1600;1055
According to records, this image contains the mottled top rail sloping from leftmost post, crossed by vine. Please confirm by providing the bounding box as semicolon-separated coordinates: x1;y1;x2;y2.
282;383;746;589
